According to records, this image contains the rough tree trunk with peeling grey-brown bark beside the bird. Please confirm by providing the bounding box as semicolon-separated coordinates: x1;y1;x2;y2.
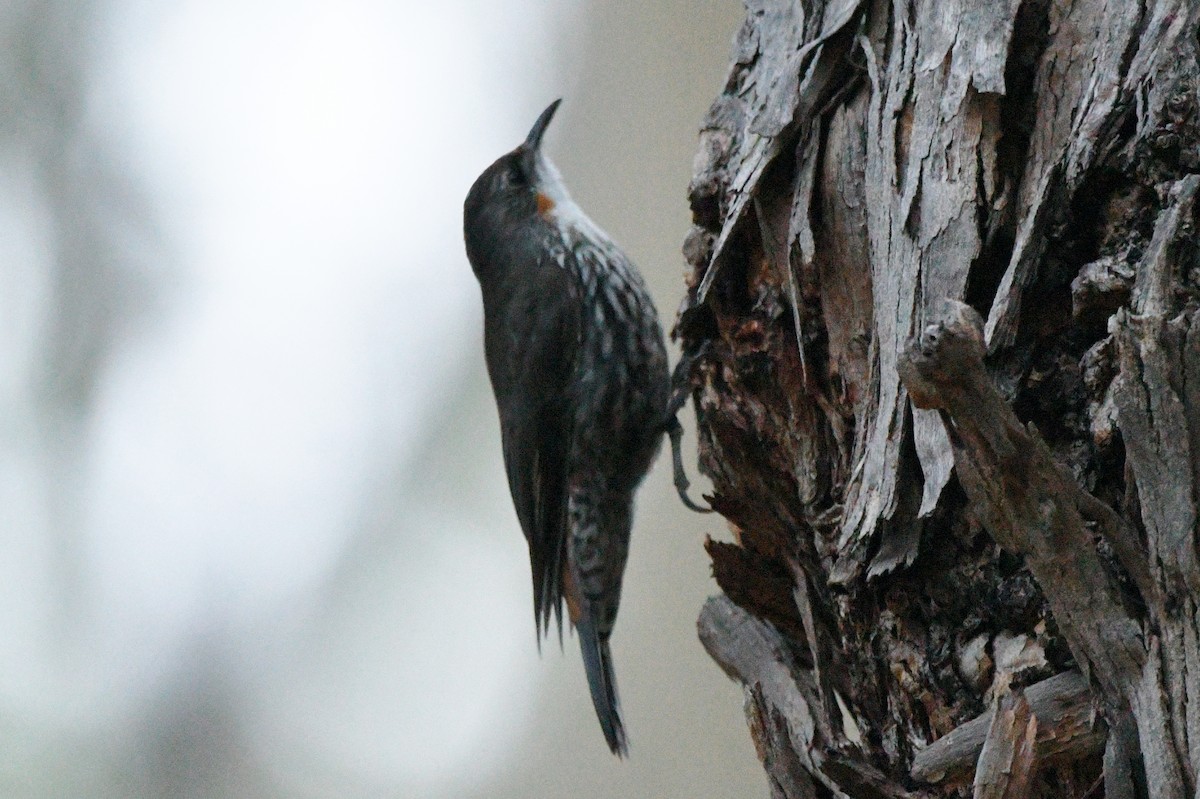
677;0;1200;799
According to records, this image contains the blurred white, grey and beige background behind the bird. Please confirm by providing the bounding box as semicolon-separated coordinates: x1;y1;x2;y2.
0;0;767;798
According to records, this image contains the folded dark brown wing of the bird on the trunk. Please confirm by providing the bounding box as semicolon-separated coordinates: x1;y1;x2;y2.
488;250;580;641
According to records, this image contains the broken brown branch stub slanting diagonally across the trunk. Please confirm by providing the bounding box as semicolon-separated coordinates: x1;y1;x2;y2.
900;300;1146;707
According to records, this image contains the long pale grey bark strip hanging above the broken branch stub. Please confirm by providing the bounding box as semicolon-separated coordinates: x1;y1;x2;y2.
840;2;1016;571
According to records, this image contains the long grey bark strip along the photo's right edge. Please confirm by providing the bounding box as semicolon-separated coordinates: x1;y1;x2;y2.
1112;175;1200;792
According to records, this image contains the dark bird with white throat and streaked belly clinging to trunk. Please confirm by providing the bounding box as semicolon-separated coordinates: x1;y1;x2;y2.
463;100;690;757
